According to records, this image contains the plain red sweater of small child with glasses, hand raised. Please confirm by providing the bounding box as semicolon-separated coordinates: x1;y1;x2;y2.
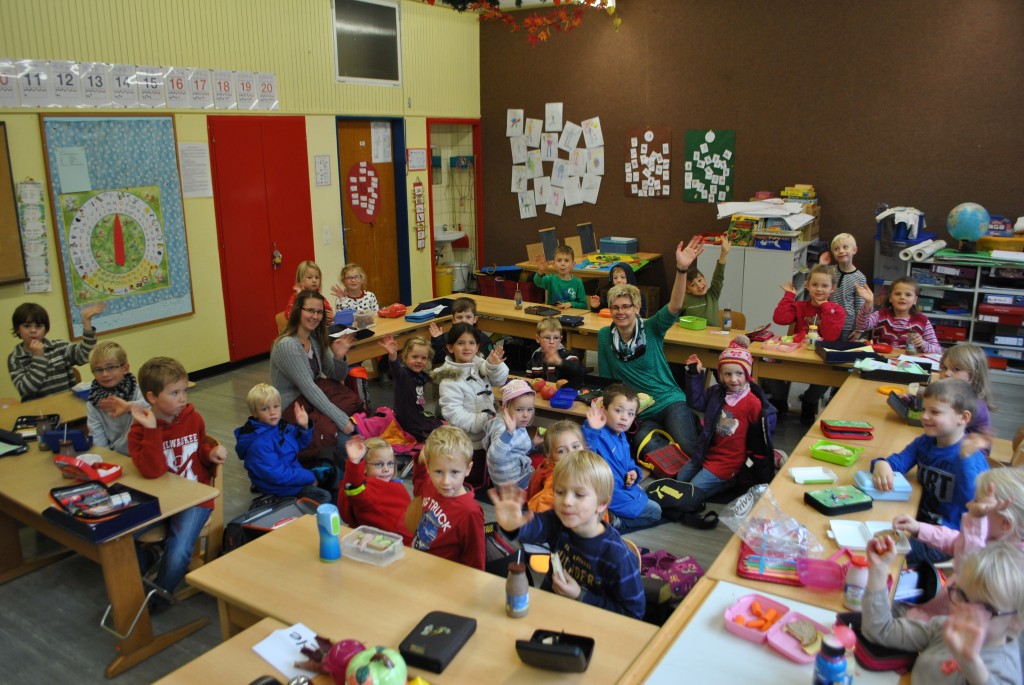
338;460;413;546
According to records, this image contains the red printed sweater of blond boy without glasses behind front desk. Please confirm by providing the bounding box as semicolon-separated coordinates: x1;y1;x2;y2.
413;480;486;570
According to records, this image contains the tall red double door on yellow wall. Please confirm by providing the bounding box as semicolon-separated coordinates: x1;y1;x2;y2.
208;117;313;361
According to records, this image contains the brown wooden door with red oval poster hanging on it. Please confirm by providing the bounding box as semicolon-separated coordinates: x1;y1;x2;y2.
337;120;401;307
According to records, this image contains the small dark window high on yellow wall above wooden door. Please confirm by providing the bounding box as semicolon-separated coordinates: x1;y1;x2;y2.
334;0;401;86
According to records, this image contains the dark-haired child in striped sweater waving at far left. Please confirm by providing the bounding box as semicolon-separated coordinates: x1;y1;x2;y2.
7;302;106;401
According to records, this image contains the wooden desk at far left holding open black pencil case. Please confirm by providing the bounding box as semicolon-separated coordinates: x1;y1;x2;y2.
0;445;219;680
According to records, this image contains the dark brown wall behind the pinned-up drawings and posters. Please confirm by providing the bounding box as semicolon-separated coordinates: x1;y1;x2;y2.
480;0;1024;288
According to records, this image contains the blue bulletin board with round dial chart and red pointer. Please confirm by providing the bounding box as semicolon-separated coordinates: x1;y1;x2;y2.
40;115;195;337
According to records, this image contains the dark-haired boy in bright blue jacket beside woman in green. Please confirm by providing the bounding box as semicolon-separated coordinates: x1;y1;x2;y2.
583;383;662;532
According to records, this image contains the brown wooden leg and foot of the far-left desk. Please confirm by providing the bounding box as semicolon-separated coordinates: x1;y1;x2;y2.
99;536;210;678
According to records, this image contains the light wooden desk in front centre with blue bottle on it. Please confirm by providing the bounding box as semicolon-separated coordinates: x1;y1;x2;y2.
188;516;655;685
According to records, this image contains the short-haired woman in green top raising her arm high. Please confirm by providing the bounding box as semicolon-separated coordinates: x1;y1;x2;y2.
597;238;703;455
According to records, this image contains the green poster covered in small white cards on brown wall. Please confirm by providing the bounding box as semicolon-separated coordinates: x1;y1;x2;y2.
683;130;736;203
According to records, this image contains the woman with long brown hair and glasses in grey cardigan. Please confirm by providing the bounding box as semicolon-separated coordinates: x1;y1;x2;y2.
270;290;361;466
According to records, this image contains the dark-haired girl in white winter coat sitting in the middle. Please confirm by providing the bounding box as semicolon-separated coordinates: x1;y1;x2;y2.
433;324;509;485
